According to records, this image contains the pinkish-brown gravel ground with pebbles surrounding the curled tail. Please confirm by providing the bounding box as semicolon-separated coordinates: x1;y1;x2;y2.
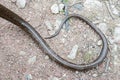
0;0;120;80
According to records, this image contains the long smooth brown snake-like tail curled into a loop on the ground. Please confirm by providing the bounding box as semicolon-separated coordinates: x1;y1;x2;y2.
0;4;108;70
